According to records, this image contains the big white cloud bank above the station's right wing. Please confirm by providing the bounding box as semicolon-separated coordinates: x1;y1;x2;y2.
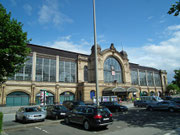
127;25;180;81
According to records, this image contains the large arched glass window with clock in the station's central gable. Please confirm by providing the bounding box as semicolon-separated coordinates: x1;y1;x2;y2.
104;57;123;83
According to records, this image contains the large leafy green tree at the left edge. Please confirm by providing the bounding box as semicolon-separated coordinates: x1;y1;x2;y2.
0;3;30;84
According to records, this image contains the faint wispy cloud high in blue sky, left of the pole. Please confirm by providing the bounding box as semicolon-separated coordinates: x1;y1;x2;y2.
38;0;73;26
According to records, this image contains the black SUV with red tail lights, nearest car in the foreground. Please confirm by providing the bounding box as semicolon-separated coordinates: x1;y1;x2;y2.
64;105;113;130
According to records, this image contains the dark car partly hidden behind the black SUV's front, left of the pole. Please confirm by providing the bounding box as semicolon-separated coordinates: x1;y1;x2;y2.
63;101;85;110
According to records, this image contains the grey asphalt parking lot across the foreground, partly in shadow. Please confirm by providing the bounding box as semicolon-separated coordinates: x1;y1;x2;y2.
4;107;180;135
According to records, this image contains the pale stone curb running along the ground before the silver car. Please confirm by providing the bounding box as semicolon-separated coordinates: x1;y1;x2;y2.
3;119;63;132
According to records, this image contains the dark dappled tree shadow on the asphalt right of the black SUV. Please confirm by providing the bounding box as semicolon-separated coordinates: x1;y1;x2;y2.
113;108;180;134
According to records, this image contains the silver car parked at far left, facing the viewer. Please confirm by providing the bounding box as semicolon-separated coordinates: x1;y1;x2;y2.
15;106;46;123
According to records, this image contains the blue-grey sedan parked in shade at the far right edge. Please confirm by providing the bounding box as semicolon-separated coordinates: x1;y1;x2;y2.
147;100;180;112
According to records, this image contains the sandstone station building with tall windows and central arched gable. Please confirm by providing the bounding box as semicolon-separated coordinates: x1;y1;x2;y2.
0;44;167;106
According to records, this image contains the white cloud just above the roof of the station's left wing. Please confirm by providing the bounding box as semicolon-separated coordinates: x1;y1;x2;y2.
46;35;91;55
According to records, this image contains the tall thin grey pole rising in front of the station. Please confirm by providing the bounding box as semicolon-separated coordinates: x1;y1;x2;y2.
93;0;99;106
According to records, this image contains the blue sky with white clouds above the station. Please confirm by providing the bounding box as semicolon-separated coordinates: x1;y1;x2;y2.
0;0;180;82
